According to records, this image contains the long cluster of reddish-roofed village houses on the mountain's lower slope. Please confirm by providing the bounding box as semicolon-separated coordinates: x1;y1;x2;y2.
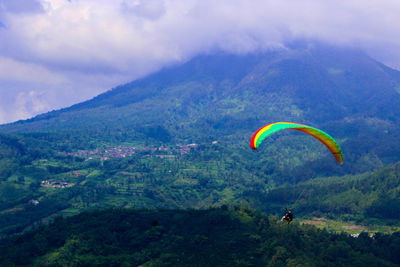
61;144;198;160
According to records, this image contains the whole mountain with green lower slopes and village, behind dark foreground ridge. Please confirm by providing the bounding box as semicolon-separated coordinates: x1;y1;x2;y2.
0;44;400;237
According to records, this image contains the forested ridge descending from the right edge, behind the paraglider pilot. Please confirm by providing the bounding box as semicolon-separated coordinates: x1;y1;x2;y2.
243;163;400;225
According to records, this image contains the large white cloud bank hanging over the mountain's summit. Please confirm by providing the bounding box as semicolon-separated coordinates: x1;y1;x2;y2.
0;0;400;72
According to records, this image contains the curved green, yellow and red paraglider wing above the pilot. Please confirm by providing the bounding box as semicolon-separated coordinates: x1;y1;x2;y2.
250;122;343;164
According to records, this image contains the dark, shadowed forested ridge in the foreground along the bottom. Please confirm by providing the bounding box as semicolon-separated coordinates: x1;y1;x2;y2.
0;207;400;266
